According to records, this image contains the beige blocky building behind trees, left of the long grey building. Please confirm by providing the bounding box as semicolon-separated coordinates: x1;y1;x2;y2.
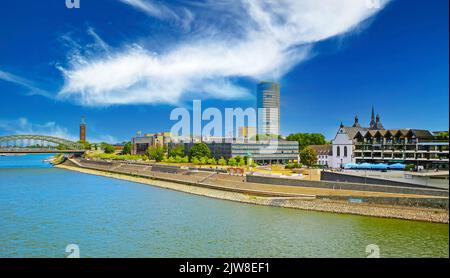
131;132;174;155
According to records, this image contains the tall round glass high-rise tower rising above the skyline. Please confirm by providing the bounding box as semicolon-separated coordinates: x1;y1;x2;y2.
256;82;281;135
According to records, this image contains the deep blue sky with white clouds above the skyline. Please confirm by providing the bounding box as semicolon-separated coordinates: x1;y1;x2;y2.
0;0;449;142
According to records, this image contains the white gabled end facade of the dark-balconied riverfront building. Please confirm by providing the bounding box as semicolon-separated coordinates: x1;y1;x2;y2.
329;126;355;168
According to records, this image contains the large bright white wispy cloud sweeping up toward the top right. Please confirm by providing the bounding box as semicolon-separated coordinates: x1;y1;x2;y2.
58;0;389;106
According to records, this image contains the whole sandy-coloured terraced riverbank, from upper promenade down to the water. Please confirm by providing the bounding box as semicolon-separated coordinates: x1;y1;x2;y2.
58;159;449;223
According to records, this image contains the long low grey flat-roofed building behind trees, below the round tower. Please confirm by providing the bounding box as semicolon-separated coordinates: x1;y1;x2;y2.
169;140;299;164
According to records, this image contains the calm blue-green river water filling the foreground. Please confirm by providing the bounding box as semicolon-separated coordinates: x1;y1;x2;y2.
0;155;449;258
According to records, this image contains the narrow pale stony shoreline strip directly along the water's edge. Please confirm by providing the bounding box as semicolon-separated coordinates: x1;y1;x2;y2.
55;164;449;224
